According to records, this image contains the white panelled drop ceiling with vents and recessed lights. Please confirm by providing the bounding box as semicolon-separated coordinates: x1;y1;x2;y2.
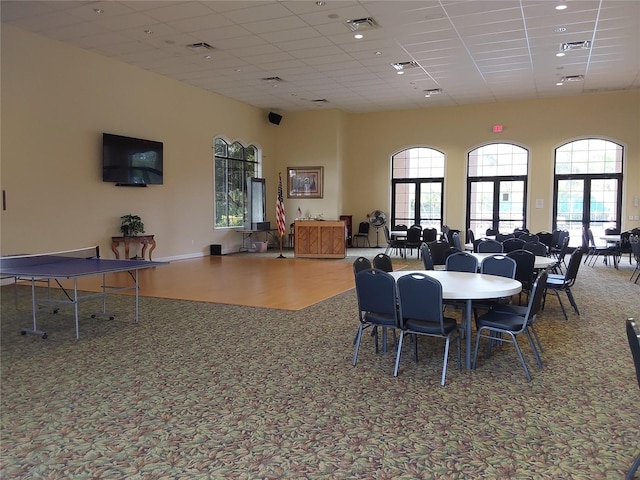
0;0;640;112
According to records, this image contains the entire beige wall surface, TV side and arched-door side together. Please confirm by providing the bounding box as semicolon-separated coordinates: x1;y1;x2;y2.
0;25;640;258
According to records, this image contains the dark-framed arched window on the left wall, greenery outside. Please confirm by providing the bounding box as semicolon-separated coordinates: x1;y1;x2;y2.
214;137;260;228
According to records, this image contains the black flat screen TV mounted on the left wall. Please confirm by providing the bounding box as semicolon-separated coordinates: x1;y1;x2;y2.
102;133;162;187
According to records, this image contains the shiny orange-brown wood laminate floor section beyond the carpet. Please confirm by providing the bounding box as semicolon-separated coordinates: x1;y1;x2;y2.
53;253;354;310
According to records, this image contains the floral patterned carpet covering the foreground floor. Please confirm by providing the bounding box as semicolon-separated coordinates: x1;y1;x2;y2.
0;250;640;480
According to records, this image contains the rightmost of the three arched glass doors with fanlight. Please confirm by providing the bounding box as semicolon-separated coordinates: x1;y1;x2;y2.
553;138;624;246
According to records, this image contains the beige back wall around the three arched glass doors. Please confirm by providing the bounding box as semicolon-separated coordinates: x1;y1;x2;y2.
344;90;640;231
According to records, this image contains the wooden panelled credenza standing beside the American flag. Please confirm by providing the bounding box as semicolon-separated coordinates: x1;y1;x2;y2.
294;220;346;258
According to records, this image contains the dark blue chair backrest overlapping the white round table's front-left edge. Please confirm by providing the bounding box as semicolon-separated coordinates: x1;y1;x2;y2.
398;273;445;335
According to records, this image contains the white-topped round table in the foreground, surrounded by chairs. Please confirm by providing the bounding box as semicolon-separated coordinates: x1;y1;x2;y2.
389;270;522;370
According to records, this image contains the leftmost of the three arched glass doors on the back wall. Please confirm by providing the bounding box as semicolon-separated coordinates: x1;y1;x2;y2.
391;147;444;230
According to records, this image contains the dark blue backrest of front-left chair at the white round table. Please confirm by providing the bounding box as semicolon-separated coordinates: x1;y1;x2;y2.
356;268;397;320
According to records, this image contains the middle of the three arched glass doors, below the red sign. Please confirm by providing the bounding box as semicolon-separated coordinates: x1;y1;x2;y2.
467;143;529;236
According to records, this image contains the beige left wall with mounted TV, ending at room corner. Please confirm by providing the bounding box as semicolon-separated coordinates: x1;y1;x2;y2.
0;24;275;258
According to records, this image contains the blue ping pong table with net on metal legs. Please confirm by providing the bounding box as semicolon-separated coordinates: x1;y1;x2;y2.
0;247;167;339
